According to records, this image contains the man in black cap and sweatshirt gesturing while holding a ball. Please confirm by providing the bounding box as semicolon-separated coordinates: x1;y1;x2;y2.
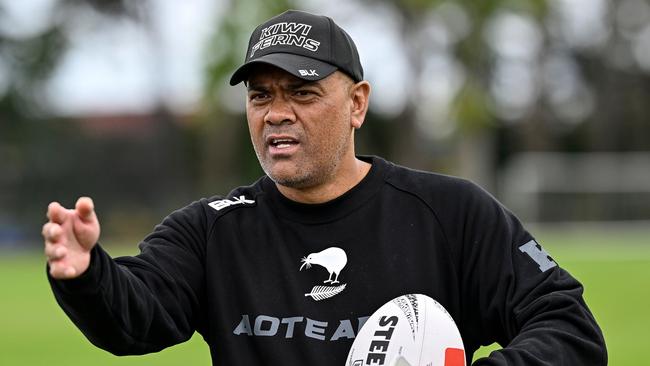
43;11;607;365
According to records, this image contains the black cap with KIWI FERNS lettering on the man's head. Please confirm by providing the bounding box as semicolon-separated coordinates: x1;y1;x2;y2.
230;10;363;85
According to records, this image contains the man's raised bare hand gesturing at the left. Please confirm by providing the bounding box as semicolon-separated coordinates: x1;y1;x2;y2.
43;197;99;279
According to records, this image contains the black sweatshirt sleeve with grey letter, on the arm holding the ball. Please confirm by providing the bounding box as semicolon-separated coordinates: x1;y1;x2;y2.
442;183;607;366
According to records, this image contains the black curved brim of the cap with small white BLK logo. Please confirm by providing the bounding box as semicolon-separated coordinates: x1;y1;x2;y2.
230;53;337;85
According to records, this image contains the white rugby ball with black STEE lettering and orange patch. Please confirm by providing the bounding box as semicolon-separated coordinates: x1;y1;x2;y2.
346;294;466;366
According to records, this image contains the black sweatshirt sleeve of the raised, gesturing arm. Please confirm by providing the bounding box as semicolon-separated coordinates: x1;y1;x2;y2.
48;203;206;355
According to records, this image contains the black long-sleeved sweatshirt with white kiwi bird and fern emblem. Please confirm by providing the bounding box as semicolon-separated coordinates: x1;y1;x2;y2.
50;157;607;366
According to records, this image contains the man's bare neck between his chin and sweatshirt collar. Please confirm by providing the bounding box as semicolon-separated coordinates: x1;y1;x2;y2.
276;159;371;204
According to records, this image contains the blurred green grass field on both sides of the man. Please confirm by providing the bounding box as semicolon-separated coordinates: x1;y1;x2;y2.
0;226;650;366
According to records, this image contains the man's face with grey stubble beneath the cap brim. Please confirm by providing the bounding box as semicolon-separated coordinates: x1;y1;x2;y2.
246;65;354;189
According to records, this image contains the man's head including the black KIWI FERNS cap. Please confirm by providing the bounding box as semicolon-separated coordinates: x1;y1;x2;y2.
231;11;370;199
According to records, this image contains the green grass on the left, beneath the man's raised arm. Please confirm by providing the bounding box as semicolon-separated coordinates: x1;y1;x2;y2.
0;247;211;366
